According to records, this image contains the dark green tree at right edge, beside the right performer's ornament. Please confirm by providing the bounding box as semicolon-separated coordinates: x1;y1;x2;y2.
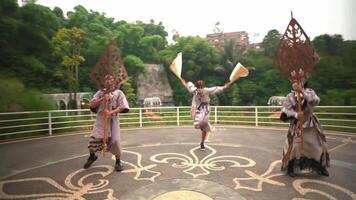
308;34;356;105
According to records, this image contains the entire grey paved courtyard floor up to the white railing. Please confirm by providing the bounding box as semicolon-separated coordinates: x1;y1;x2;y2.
0;127;356;200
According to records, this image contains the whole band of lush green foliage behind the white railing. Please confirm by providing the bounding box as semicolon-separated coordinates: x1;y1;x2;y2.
0;0;356;111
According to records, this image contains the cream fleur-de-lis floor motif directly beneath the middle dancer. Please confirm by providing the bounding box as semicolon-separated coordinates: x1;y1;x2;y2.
150;145;256;178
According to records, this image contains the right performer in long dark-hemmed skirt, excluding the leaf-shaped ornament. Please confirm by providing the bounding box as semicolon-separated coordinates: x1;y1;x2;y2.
280;83;330;177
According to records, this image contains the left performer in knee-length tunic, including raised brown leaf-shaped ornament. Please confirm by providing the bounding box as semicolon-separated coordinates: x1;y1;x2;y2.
84;40;129;171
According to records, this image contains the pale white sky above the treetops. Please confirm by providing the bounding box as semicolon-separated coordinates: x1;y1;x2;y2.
32;0;356;43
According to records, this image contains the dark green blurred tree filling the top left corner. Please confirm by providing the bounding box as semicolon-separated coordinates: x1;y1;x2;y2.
0;1;60;89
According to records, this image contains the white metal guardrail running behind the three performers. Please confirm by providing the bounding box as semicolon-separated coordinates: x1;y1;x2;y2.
0;106;356;139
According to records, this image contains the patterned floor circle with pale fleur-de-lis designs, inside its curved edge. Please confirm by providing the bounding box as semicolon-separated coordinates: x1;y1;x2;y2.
0;143;356;200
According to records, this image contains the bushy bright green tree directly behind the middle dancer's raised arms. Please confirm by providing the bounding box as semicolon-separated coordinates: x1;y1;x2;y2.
159;37;223;105
